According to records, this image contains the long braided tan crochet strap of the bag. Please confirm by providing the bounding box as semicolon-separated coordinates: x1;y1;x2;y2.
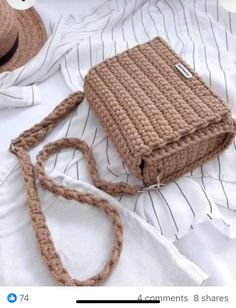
10;92;140;286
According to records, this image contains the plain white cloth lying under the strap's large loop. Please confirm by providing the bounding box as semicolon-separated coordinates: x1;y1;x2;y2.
0;152;207;286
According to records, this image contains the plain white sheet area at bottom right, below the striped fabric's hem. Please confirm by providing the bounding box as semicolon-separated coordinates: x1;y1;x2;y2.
175;219;236;286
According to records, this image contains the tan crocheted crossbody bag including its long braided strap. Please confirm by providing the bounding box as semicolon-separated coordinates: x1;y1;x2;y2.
10;38;236;286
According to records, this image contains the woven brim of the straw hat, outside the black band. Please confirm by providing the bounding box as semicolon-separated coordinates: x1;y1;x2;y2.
0;8;47;73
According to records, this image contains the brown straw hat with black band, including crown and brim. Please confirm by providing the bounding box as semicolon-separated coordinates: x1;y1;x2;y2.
0;0;47;73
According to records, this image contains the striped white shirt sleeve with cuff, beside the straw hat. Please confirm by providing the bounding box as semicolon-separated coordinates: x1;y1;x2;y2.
0;1;112;108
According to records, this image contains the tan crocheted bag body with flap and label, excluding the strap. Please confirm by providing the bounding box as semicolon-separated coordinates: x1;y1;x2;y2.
84;37;236;185
